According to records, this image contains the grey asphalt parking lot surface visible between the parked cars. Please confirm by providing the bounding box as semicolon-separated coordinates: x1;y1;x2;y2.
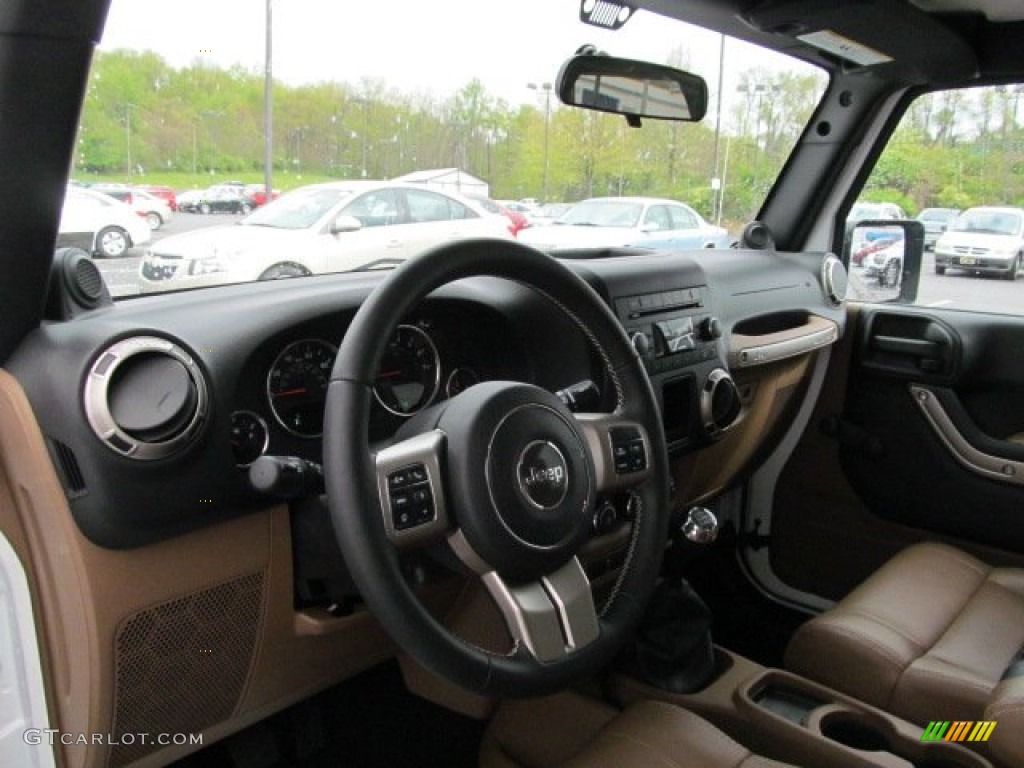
96;213;1024;314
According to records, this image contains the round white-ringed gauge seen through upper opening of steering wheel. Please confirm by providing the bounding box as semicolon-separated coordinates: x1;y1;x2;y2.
374;326;441;416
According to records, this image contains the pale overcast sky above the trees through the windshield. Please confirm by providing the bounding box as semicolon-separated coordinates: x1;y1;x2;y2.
100;0;815;112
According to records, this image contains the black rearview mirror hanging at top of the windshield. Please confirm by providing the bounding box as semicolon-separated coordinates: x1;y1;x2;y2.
555;53;708;123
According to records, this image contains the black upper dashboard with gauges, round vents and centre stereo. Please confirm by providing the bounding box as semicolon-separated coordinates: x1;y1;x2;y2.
9;250;844;549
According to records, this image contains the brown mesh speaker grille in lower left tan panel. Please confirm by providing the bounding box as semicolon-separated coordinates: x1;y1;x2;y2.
109;571;263;766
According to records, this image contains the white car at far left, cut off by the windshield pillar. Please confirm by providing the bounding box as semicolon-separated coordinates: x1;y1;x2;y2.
57;186;151;258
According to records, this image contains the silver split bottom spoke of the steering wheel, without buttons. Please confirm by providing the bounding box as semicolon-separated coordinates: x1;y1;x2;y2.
482;557;599;663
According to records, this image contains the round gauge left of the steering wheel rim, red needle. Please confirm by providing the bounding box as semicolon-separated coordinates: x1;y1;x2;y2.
266;339;338;437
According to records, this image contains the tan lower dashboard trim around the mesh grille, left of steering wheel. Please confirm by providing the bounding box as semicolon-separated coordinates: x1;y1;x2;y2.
0;370;419;768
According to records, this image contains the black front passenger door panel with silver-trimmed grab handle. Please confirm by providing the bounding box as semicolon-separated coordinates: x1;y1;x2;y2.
770;305;1024;599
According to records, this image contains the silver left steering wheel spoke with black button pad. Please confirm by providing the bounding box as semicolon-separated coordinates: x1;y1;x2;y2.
375;430;451;548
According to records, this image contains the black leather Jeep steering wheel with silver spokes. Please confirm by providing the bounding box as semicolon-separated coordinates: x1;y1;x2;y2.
324;240;669;695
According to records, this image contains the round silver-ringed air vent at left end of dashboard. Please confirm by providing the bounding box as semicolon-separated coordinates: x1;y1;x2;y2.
83;336;209;461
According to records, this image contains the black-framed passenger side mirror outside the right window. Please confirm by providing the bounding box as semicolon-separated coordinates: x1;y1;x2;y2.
844;219;925;303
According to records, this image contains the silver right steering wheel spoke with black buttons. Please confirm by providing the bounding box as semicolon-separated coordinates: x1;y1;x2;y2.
575;414;651;492
